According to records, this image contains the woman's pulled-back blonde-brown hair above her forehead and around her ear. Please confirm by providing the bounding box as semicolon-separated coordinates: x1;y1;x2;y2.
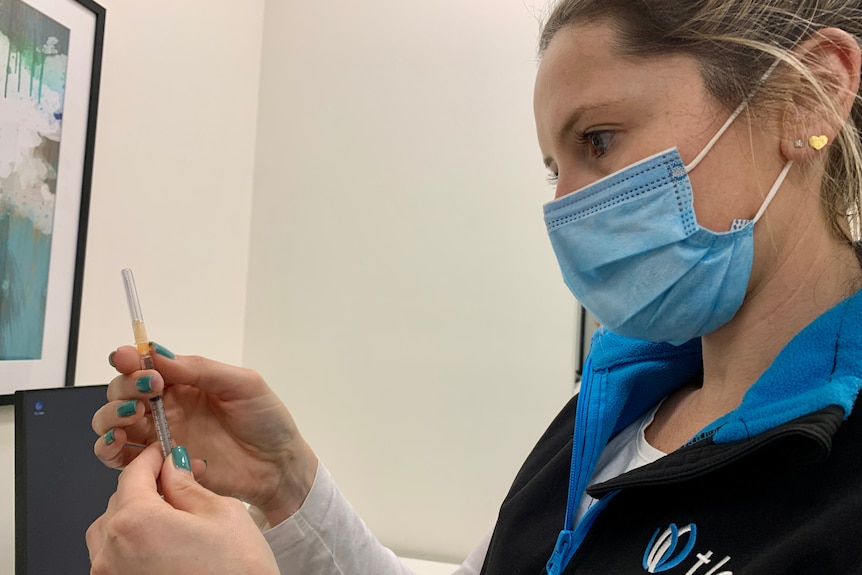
539;0;862;243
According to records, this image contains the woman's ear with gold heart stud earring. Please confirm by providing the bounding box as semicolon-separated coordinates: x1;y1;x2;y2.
781;28;862;162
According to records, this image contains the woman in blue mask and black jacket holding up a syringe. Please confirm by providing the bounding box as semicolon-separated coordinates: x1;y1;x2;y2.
87;0;862;575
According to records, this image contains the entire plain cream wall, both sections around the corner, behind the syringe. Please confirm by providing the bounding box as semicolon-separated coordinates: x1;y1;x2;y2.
0;0;574;572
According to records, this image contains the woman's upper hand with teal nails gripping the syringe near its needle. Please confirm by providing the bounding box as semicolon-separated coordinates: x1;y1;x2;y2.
93;345;317;525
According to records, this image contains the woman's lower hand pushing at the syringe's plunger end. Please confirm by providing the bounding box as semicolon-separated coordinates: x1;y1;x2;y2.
87;445;278;575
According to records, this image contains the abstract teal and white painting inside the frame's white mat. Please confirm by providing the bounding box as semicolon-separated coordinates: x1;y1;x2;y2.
0;0;69;361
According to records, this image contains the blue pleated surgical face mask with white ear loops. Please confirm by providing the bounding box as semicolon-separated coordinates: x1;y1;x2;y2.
544;98;792;345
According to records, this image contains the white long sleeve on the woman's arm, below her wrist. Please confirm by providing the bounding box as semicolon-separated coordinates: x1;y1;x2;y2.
263;463;490;575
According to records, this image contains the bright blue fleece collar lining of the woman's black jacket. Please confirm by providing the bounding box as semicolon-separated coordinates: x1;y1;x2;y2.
585;290;862;443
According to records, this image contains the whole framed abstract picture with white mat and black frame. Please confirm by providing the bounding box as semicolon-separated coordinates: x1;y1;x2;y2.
0;0;105;404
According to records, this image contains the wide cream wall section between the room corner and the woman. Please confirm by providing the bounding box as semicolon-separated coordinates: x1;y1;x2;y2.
244;0;574;562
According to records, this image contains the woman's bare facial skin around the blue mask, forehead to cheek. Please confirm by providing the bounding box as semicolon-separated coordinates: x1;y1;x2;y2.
534;22;784;231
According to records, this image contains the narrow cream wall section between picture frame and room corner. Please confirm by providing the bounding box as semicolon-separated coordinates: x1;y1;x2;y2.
0;0;264;573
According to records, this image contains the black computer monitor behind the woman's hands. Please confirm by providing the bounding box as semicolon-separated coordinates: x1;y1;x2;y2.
15;385;119;575
